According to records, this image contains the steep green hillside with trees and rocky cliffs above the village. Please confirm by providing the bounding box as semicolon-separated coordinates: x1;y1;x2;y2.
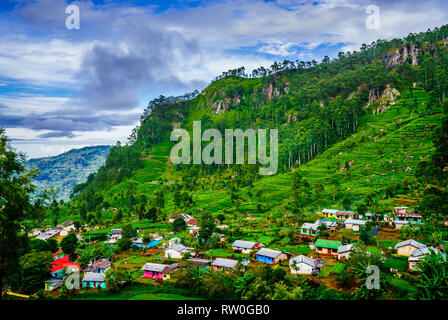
55;26;448;229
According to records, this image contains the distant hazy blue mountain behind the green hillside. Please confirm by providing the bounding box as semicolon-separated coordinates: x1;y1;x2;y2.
27;146;110;201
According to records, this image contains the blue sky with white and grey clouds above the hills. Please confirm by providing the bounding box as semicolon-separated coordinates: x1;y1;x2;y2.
0;0;448;158
